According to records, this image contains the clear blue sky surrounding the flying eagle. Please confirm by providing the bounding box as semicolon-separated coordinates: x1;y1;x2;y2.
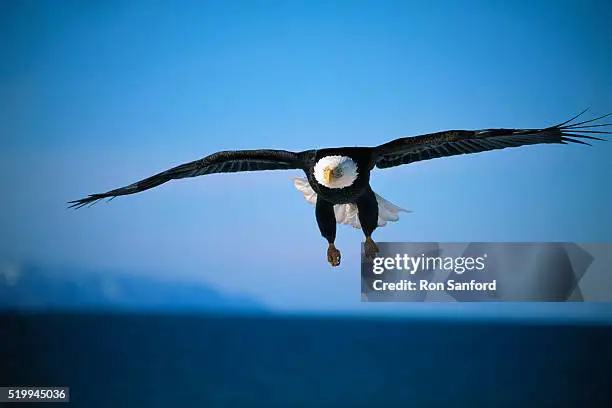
0;1;612;314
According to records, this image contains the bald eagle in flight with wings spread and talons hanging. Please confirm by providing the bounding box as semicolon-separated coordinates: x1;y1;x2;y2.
68;109;612;267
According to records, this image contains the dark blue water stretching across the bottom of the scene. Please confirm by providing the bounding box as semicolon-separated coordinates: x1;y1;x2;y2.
0;314;612;408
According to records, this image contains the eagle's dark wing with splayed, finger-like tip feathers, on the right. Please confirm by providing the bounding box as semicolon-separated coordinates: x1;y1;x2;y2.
373;110;612;169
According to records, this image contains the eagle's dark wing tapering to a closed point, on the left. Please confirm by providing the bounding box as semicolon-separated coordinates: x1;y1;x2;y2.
68;149;308;208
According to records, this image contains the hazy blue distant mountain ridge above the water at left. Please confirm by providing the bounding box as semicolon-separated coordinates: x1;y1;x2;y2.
0;264;266;312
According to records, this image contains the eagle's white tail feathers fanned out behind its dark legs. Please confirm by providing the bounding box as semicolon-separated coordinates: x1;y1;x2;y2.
293;177;410;228
